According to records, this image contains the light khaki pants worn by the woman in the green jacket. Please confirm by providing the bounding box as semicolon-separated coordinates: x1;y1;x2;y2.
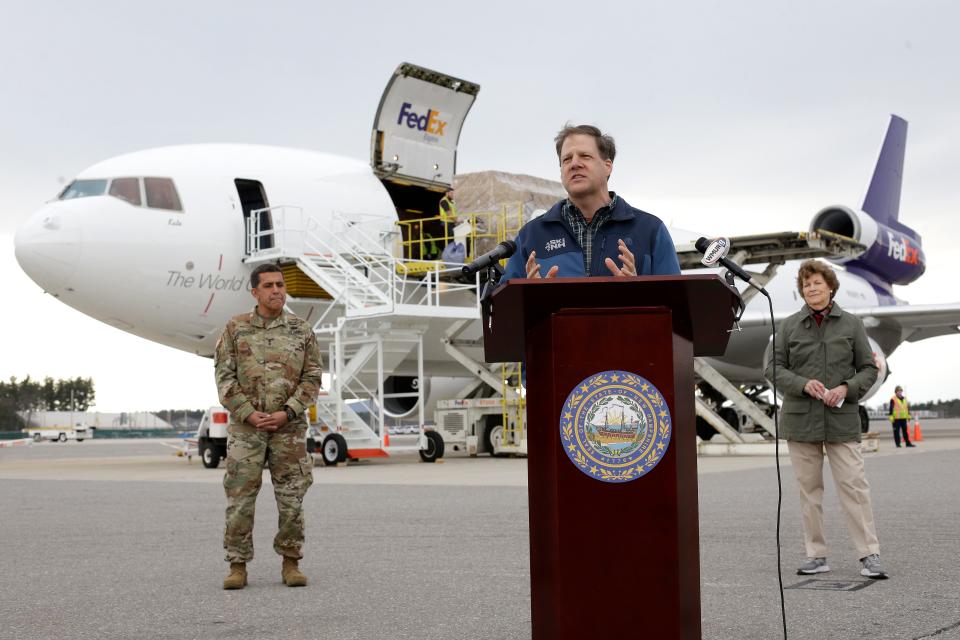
789;440;880;558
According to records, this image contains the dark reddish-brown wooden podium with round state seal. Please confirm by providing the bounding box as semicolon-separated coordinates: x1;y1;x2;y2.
484;275;739;640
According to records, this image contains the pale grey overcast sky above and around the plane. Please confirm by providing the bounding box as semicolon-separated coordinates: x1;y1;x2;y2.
0;0;960;411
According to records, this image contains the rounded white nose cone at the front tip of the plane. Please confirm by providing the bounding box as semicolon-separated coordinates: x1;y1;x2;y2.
13;207;81;294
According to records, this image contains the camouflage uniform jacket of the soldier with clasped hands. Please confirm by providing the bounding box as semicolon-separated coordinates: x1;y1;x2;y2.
214;308;323;428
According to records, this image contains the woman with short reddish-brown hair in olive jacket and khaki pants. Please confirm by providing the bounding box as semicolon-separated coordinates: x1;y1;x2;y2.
766;260;887;578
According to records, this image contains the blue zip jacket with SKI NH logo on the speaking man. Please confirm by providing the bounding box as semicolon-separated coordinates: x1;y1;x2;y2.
503;197;680;282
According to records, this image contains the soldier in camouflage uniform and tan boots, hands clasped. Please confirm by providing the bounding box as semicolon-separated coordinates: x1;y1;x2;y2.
214;264;322;589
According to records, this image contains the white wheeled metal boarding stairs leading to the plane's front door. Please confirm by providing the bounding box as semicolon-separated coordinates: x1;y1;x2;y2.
245;206;510;464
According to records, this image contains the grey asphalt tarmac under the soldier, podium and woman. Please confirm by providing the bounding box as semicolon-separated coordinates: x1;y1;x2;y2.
0;421;960;640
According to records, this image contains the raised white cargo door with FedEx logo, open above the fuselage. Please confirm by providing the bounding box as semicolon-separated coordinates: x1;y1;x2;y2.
370;63;480;192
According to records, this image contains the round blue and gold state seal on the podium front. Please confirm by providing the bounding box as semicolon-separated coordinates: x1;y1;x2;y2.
560;371;672;482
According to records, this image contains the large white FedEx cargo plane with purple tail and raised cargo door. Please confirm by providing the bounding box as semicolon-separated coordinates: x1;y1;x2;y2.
15;64;960;448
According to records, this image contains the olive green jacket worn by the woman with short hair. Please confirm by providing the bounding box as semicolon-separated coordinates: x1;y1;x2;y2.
765;302;877;442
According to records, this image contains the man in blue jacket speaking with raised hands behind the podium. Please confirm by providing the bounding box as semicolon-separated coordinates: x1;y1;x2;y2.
503;124;680;281
